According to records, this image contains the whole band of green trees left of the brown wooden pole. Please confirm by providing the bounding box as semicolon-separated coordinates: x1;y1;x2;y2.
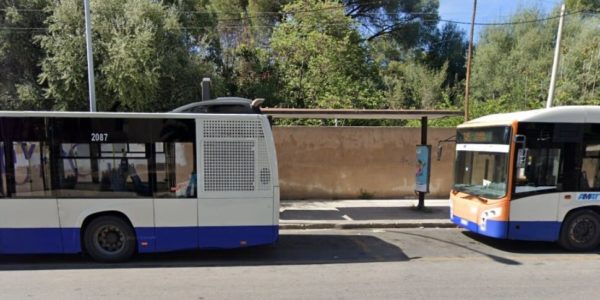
0;0;465;123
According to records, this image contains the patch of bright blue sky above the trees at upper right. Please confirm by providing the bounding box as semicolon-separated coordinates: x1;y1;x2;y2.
438;0;563;42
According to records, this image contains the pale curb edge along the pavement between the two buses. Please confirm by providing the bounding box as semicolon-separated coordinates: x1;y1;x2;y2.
279;221;458;230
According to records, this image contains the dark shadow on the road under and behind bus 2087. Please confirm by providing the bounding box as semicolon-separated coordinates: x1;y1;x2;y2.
0;234;409;271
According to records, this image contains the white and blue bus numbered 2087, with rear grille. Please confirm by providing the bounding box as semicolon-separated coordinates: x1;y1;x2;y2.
0;111;279;261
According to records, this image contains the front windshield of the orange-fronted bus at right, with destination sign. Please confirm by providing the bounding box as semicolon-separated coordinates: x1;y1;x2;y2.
454;127;510;199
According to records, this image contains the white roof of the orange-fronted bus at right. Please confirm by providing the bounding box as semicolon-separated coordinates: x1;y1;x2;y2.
459;105;600;127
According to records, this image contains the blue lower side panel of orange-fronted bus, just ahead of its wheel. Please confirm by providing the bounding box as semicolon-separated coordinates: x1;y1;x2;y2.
508;221;561;242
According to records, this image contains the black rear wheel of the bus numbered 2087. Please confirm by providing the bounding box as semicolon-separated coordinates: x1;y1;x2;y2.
83;216;136;262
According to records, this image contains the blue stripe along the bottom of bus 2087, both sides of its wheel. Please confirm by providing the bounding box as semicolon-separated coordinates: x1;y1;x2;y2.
0;225;279;254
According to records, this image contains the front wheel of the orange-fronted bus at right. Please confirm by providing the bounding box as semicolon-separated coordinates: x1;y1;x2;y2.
558;209;600;251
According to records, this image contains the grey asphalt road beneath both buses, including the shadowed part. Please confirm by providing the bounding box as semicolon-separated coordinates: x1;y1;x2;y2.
0;229;600;299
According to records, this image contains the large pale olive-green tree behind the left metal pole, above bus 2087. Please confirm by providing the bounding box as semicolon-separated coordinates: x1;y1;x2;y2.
39;0;216;111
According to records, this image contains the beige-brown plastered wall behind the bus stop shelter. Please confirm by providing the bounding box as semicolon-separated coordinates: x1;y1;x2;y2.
273;127;455;199
